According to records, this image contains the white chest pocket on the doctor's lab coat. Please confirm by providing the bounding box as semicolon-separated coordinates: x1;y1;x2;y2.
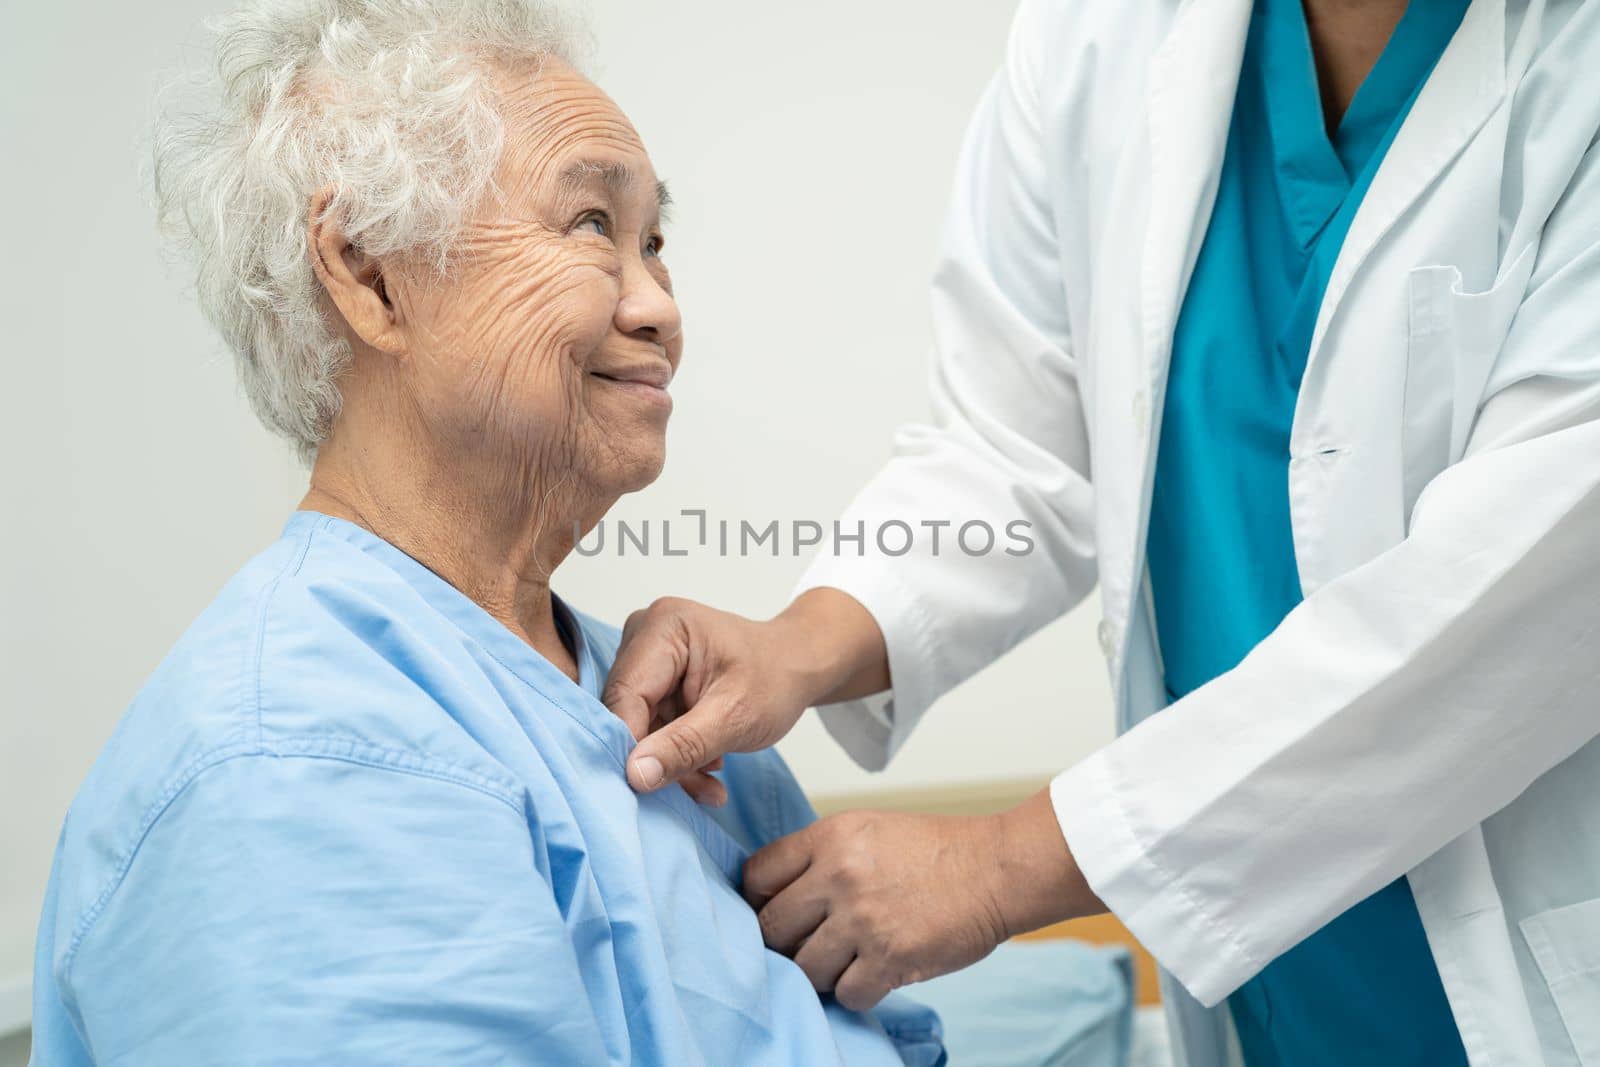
1402;245;1538;525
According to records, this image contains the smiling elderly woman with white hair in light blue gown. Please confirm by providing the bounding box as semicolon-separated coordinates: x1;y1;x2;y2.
34;0;942;1067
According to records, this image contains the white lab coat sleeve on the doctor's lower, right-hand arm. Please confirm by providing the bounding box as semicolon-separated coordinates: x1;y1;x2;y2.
1051;156;1600;1005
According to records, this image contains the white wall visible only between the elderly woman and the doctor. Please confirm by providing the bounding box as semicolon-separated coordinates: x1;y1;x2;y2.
563;0;1112;792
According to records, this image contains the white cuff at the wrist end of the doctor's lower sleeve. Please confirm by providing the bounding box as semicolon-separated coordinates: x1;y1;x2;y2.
1050;745;1261;1008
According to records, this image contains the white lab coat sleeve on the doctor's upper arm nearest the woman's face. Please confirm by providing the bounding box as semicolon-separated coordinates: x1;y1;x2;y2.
800;0;1094;769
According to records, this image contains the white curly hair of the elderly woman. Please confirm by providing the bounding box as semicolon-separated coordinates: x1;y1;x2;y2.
154;0;587;462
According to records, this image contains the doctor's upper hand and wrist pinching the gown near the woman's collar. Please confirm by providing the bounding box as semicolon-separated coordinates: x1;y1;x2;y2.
602;589;890;803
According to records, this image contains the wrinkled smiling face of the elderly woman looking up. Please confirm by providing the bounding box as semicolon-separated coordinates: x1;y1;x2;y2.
392;61;683;504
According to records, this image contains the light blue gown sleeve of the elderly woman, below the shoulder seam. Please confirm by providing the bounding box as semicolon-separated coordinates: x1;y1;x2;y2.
58;755;611;1067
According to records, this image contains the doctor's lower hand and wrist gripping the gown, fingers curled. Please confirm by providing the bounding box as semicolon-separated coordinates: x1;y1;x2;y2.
744;790;1106;1011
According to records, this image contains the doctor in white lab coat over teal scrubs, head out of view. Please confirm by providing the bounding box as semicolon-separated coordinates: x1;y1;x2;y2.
608;0;1600;1067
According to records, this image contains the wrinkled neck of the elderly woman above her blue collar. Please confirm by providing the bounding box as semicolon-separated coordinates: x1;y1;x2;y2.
301;428;601;678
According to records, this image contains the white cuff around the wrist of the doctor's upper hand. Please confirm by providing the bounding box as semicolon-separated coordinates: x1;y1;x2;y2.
795;555;942;771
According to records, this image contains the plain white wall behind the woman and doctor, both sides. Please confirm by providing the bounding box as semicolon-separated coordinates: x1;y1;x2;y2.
0;0;1110;1029
